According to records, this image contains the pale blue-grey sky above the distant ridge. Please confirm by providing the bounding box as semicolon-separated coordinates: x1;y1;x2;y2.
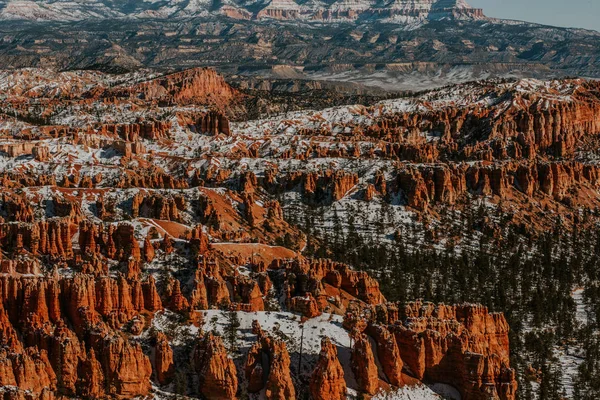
467;0;600;31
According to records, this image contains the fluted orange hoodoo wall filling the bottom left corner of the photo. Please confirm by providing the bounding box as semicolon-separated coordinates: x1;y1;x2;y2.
0;274;159;398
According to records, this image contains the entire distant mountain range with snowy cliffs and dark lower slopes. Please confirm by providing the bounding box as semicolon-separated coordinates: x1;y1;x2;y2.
0;0;600;90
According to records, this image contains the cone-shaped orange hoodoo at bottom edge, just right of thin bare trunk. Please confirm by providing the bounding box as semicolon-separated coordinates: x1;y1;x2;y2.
310;338;346;400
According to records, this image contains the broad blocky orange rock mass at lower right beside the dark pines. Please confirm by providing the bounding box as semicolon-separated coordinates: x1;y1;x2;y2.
391;303;517;400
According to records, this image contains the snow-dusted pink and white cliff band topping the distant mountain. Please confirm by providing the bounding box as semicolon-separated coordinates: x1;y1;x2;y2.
0;0;484;23
